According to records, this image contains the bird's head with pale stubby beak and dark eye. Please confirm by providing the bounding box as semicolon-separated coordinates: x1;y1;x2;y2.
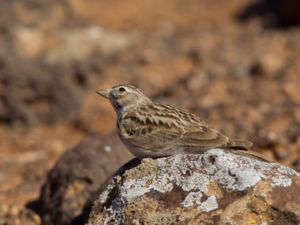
96;85;152;113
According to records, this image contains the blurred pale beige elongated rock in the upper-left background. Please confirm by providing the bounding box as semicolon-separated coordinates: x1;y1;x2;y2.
46;26;130;64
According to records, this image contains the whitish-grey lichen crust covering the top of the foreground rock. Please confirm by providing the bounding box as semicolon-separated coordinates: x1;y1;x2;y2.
96;149;300;224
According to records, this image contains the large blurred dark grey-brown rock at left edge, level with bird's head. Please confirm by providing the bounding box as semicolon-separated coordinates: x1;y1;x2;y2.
0;58;86;126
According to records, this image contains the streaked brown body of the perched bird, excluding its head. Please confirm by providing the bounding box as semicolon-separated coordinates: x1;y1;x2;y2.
118;104;252;158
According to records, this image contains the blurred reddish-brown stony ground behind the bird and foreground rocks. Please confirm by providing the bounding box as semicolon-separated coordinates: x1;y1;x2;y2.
0;0;300;225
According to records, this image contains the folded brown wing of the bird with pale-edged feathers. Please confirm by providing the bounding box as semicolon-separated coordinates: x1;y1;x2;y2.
121;109;228;151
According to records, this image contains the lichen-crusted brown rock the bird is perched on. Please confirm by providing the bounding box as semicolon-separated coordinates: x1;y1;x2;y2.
88;149;300;225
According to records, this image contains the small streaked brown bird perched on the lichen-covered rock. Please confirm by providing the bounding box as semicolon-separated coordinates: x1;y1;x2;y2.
96;85;263;159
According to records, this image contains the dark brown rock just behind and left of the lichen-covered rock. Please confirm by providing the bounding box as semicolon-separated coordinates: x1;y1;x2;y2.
35;135;130;225
